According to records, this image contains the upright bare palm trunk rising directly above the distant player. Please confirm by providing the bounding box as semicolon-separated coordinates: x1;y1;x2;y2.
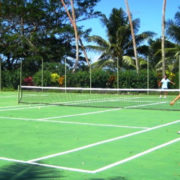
161;0;166;76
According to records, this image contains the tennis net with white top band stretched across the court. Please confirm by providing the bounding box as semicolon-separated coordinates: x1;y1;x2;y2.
18;86;180;111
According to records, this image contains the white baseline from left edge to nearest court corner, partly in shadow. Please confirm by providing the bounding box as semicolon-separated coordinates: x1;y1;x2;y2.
0;157;94;173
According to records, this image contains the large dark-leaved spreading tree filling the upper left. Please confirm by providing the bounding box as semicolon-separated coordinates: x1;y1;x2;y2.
0;0;99;72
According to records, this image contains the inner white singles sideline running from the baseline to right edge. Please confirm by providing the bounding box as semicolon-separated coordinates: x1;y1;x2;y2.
28;120;180;162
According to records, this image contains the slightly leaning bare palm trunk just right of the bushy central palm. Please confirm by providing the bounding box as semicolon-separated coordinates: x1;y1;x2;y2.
125;0;139;74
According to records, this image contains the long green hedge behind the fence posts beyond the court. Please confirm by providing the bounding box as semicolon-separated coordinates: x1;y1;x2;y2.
2;69;176;89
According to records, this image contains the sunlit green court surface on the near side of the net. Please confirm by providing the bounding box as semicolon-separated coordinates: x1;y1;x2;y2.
0;92;180;180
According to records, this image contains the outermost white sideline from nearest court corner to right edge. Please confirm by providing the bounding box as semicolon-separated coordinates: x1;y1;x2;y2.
94;138;180;173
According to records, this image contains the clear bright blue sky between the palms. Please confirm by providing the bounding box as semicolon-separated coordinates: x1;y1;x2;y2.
78;0;180;61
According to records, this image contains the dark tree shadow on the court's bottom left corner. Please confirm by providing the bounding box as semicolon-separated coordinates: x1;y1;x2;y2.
0;163;63;180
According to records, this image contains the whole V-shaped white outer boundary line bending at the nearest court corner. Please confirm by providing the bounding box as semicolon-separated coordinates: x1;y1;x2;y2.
0;138;180;174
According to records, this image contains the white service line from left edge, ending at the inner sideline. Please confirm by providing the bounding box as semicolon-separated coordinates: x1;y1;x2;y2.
0;117;148;129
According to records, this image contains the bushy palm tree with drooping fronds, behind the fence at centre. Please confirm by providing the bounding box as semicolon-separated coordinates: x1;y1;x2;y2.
88;8;153;69
